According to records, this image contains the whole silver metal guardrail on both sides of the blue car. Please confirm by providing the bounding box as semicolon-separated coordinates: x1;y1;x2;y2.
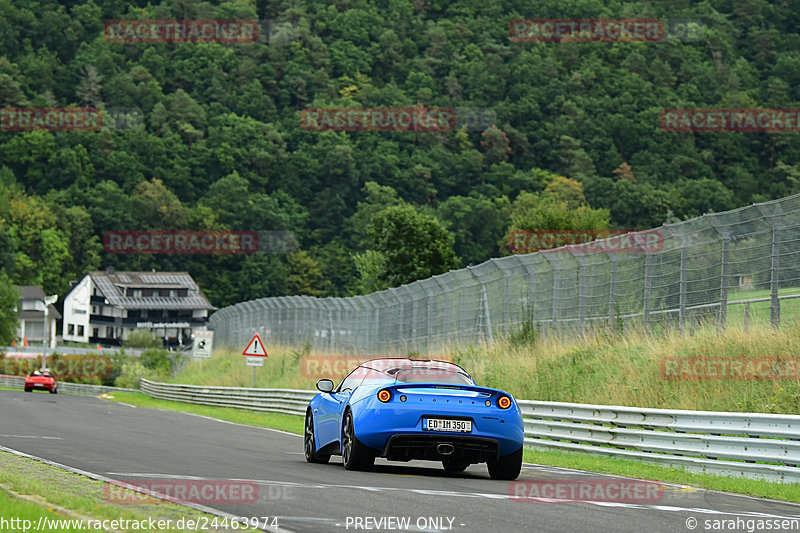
140;379;800;483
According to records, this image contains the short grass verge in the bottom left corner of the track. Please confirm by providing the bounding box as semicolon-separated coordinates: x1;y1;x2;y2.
0;452;252;533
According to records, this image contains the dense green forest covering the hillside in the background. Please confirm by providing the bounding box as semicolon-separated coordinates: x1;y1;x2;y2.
0;0;800;307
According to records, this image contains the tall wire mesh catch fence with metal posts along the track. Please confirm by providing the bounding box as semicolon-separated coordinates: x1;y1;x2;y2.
209;195;800;355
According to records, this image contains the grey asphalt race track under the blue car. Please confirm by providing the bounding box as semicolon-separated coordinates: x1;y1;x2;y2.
0;390;800;533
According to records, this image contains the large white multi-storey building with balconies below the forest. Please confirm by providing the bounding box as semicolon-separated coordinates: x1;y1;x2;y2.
62;268;214;346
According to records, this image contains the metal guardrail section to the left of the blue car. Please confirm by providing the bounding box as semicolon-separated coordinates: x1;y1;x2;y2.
139;379;316;416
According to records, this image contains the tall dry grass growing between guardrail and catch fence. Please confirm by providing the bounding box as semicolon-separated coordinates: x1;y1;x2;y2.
176;320;800;414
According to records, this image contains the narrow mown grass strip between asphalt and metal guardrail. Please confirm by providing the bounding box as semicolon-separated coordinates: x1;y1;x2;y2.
101;393;800;503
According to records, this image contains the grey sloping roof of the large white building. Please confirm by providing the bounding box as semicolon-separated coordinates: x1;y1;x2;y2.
88;271;216;310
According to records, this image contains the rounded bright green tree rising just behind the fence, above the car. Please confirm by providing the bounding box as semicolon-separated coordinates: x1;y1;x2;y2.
368;205;458;287
